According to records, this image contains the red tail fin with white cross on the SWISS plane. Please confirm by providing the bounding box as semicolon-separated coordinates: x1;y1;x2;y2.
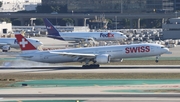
15;34;36;51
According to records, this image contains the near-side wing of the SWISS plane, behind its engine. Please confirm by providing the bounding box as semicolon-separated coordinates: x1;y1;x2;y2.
49;52;96;61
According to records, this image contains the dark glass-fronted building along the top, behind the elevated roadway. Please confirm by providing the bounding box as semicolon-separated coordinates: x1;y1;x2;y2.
42;0;180;13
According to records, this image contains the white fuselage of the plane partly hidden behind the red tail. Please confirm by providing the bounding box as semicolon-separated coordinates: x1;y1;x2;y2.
0;38;42;49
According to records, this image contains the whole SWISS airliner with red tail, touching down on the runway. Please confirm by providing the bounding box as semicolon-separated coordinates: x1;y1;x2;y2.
15;34;169;68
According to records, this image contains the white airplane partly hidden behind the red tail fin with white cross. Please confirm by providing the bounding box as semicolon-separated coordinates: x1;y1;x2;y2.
0;38;43;52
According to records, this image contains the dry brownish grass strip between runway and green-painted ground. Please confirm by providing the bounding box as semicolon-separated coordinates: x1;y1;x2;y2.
0;73;180;87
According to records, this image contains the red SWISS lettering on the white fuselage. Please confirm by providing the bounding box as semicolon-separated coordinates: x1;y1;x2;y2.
125;46;150;54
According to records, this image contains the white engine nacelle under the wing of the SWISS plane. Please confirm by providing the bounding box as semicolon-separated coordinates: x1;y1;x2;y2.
95;54;110;64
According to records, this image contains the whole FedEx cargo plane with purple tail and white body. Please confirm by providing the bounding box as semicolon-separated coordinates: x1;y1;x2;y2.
43;18;127;42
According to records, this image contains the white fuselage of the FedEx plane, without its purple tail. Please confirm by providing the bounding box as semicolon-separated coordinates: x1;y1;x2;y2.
59;32;127;41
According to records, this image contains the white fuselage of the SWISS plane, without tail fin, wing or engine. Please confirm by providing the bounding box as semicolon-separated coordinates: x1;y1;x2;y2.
21;43;169;63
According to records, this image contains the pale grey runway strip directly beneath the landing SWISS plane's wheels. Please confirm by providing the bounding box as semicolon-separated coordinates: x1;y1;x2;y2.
0;65;180;74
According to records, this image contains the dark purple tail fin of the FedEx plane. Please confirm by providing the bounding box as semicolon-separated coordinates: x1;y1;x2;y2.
43;18;64;40
